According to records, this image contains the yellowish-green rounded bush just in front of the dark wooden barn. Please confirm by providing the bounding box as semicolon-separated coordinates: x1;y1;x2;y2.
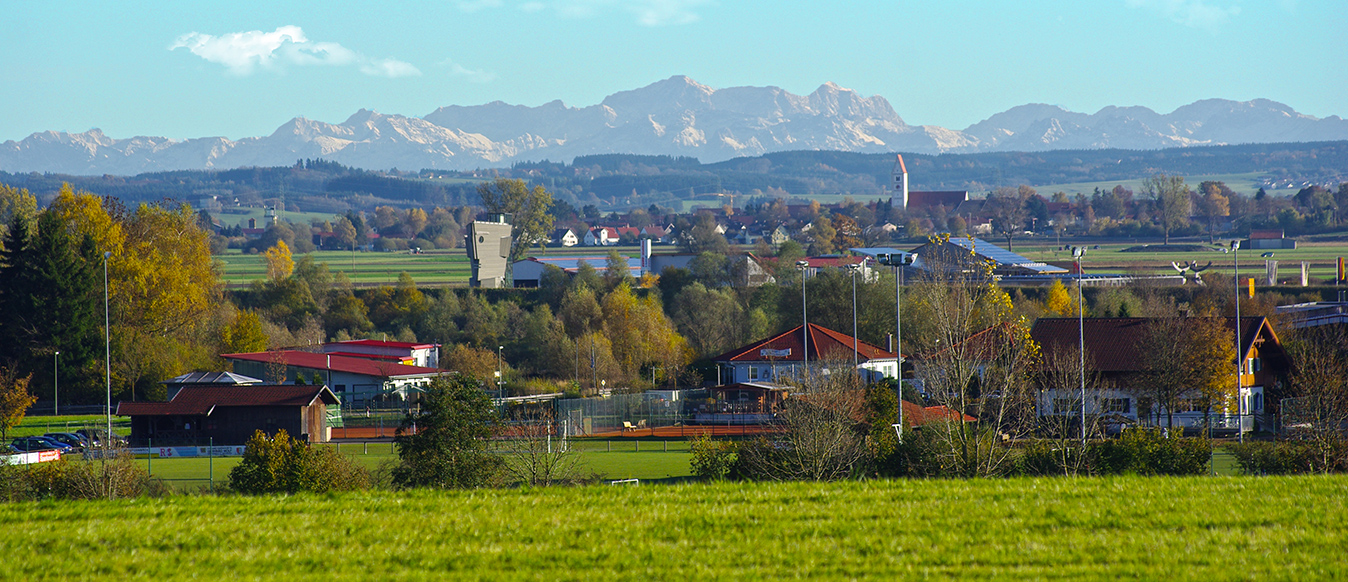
229;430;369;494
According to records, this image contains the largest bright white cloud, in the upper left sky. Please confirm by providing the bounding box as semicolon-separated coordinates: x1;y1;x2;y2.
169;26;421;78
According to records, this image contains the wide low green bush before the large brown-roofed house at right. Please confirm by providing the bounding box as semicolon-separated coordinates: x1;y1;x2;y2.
1088;428;1212;476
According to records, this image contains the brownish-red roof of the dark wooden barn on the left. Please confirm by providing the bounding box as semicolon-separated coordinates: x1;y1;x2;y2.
117;384;341;416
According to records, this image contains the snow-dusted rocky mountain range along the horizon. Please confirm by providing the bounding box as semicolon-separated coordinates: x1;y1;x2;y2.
0;77;1348;175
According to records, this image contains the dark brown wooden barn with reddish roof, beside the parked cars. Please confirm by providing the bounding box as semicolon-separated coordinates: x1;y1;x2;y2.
117;384;338;446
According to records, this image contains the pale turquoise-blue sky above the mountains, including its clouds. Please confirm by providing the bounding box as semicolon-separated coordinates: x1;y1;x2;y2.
0;0;1348;140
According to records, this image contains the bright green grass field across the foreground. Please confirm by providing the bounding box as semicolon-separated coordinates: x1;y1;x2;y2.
0;476;1348;581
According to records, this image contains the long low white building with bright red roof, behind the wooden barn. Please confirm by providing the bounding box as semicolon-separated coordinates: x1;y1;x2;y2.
220;350;452;406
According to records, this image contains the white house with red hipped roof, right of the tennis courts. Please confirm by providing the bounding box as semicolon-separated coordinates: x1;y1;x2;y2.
712;323;898;384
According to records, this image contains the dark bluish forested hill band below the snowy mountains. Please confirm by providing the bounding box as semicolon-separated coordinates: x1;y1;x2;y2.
0;141;1348;213
